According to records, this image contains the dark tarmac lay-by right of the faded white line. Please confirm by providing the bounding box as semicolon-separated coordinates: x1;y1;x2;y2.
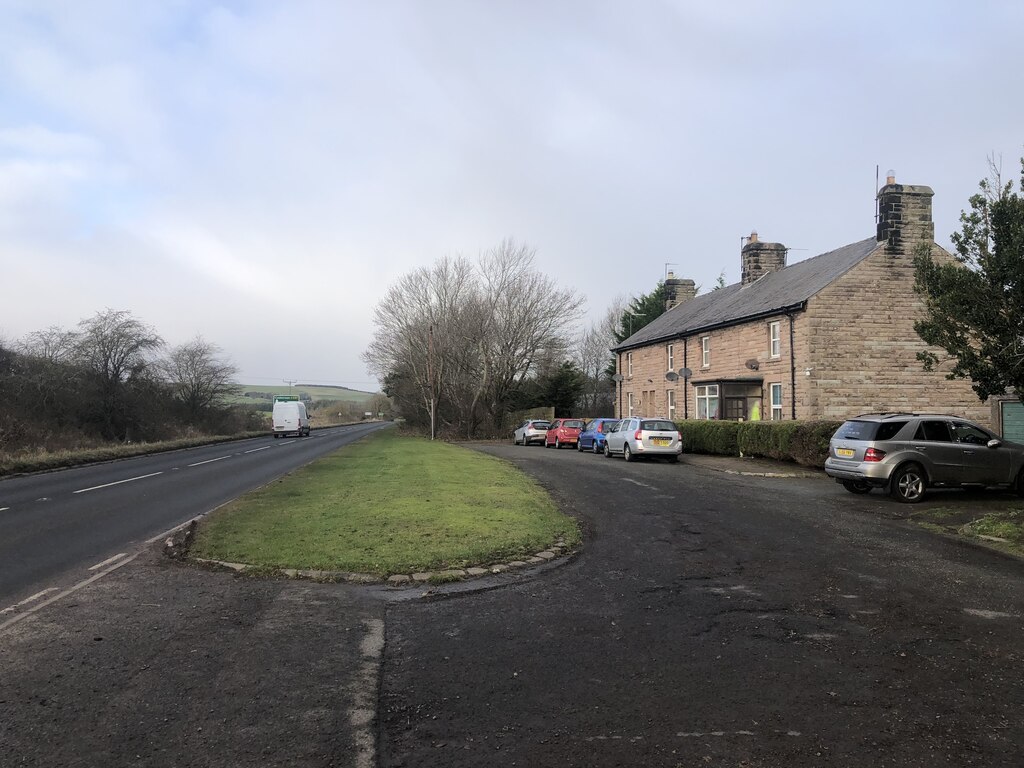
380;445;1024;768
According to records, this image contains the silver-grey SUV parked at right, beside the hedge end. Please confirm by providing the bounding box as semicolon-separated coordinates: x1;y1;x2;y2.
825;414;1024;504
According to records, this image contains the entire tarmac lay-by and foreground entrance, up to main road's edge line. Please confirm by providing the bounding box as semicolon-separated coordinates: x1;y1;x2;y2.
0;443;1024;768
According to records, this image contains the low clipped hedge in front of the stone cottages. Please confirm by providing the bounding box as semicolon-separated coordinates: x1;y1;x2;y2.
677;421;843;468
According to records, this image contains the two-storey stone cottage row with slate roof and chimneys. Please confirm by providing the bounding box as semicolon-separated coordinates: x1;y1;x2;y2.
612;176;991;425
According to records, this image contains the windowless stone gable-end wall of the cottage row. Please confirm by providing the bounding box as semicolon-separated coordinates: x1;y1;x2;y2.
800;243;992;426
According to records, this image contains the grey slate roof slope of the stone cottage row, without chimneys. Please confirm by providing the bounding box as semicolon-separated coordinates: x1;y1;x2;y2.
611;237;880;351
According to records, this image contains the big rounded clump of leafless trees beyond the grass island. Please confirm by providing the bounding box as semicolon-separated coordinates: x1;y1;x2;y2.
364;240;583;436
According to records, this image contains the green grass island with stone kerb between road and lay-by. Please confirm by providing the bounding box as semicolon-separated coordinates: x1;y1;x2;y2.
191;430;580;577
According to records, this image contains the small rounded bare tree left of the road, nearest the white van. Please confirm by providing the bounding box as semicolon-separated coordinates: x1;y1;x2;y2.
160;336;239;424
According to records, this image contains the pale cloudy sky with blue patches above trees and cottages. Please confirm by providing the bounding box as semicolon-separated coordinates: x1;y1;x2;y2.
0;0;1024;391
